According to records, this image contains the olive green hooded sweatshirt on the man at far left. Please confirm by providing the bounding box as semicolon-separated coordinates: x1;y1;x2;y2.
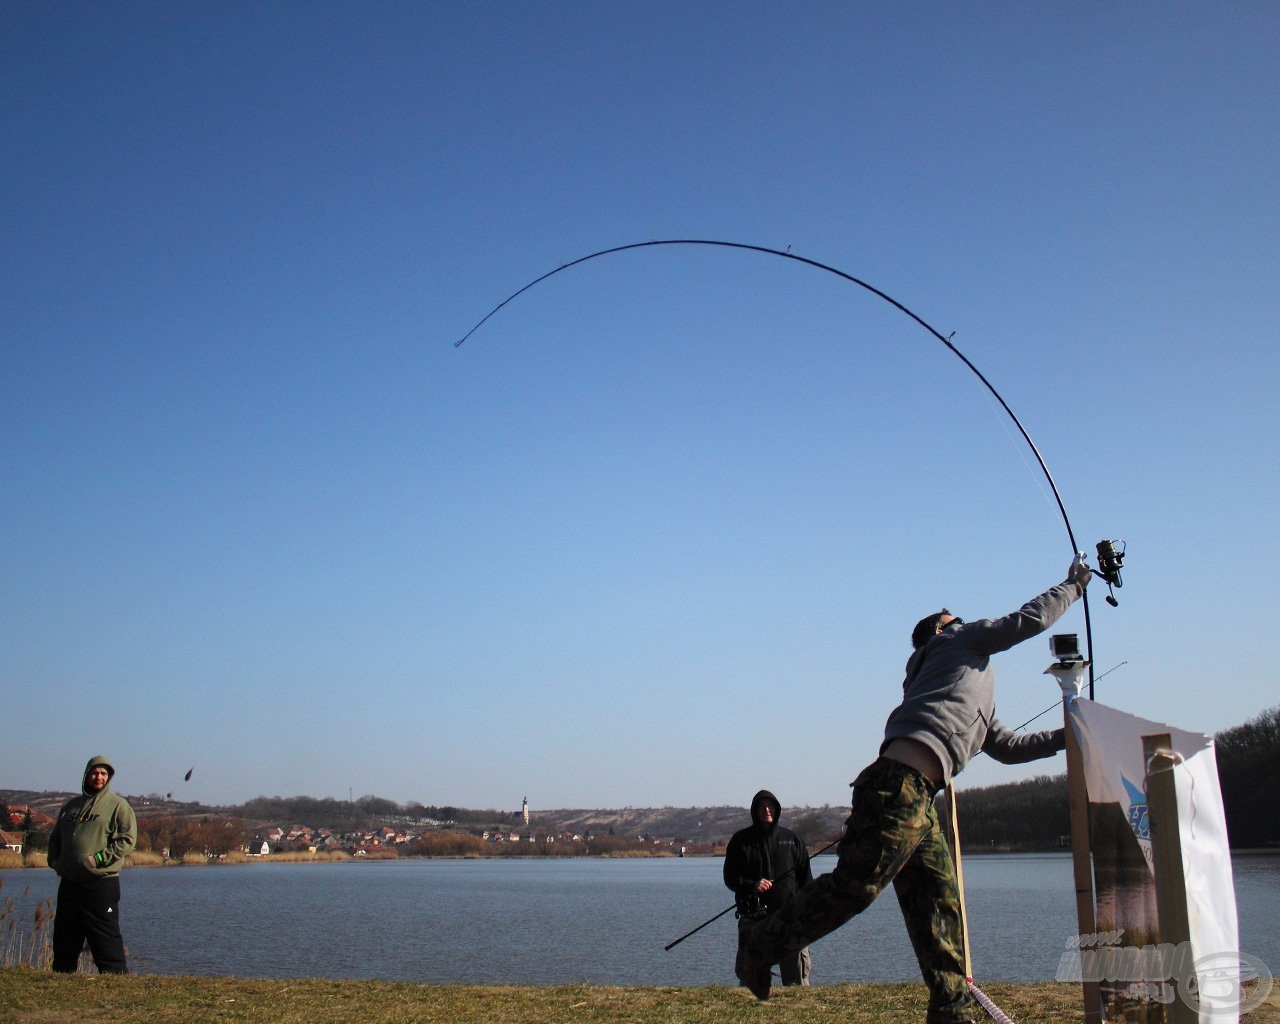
49;756;138;882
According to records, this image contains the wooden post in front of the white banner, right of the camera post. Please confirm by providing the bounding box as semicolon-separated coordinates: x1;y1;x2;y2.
1142;732;1199;1024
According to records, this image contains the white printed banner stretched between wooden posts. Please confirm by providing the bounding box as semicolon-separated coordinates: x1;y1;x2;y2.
1060;698;1249;1024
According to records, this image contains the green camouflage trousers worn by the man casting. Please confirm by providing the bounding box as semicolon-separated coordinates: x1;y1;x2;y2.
741;758;980;1024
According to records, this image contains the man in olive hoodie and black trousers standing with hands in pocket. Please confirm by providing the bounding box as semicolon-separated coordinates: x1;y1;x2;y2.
49;756;138;974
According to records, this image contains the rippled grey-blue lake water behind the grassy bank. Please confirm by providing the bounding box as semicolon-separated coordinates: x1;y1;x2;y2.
0;854;1280;986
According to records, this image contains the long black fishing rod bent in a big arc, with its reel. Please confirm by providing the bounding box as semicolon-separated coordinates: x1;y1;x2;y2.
453;238;1124;686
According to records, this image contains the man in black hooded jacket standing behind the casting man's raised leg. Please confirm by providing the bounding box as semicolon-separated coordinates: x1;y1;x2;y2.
724;790;813;984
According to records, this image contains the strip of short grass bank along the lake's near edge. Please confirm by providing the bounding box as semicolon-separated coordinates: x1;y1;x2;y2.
0;968;1280;1024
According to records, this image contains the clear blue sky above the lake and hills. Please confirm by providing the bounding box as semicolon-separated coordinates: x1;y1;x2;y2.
0;3;1280;809
